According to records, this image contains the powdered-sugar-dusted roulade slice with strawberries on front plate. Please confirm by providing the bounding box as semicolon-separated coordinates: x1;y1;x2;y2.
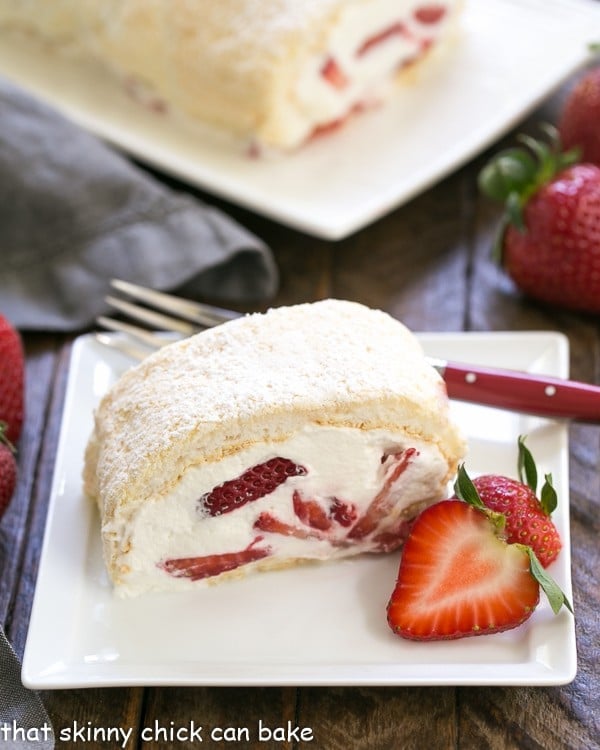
84;300;465;596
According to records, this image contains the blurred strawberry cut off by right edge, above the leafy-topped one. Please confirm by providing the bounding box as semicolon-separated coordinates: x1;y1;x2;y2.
558;66;600;166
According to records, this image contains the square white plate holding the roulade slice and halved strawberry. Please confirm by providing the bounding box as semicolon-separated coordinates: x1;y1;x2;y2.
22;333;576;689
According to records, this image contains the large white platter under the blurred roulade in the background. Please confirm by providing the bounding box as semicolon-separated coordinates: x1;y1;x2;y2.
0;0;600;239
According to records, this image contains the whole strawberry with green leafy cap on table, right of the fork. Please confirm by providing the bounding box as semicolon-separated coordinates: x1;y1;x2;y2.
480;128;600;313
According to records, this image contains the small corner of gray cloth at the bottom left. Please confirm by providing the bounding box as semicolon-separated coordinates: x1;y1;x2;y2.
0;627;54;750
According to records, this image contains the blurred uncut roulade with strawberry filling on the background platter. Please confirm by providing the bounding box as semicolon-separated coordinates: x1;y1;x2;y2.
0;0;461;151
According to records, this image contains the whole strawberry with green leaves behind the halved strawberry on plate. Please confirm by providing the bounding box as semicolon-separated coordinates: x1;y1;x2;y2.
455;437;562;568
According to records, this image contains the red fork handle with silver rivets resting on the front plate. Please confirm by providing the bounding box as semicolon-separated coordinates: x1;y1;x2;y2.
437;362;600;423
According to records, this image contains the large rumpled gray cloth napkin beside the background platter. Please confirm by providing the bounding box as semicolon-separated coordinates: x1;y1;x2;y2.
0;79;278;331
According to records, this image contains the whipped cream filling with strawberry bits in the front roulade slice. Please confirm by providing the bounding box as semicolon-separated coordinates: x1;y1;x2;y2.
103;426;448;596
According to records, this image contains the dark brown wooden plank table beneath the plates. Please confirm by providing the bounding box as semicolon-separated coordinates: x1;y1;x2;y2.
0;67;600;750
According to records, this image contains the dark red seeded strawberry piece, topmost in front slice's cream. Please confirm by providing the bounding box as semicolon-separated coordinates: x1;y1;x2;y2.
200;456;306;516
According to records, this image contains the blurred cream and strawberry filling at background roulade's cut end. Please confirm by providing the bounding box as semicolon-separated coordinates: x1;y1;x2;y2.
263;0;457;147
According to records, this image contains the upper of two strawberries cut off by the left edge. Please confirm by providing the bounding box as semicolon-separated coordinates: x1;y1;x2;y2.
0;315;25;444
